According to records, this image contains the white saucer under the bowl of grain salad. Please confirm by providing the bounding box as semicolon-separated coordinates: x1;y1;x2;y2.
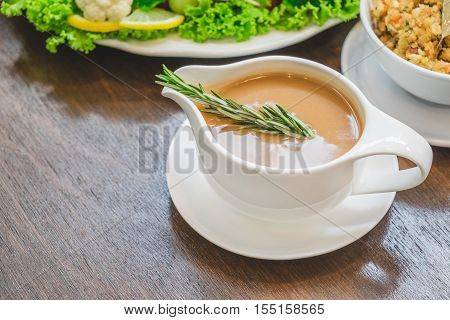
341;23;450;148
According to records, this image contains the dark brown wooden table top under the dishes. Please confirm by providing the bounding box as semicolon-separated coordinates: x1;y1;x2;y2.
0;17;450;299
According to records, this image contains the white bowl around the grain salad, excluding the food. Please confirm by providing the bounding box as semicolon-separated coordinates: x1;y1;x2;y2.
360;0;450;105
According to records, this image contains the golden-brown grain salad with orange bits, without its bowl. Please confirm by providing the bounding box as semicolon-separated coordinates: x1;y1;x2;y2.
371;0;450;74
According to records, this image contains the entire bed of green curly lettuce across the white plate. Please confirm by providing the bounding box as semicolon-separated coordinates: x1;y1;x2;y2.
0;0;359;53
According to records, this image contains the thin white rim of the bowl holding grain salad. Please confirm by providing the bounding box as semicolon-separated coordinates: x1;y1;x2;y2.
359;0;450;81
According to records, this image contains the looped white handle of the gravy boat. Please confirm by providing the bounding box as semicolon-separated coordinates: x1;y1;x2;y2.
351;110;433;195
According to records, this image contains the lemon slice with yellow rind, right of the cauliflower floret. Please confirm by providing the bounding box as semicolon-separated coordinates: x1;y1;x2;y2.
119;8;184;30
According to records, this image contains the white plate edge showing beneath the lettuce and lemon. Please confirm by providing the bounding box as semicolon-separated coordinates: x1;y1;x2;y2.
97;19;341;58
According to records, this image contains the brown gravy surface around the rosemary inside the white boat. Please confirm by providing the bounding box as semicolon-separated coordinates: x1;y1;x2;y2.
202;73;362;169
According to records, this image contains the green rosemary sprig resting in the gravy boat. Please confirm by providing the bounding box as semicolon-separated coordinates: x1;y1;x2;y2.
156;65;314;139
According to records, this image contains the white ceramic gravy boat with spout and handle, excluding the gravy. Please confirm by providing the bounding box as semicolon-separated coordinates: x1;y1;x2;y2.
162;56;432;211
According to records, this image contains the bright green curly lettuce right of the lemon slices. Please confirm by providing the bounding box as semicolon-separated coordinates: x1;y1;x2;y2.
179;0;359;42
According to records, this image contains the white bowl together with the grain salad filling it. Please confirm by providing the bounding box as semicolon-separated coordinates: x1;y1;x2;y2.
360;0;450;104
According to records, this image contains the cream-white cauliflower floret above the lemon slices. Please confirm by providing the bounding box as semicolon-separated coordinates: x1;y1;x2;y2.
75;0;133;21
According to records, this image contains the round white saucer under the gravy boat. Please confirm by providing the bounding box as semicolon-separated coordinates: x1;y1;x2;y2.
167;121;398;260
